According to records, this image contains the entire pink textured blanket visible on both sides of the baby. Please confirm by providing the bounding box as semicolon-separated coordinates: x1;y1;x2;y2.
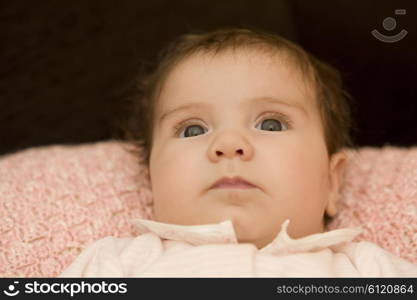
0;141;417;277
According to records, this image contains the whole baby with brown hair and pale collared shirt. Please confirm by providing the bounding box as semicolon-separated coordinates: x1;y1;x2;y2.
60;29;417;277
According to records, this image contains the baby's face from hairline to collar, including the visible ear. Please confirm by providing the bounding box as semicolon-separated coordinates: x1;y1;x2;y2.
149;51;344;248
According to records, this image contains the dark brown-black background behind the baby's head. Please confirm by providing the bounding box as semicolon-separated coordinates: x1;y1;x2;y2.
0;0;417;154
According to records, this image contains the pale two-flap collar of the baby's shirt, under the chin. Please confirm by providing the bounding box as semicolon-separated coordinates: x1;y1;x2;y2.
131;219;362;255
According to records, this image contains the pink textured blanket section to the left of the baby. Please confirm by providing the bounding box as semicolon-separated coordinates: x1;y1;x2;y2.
0;142;152;277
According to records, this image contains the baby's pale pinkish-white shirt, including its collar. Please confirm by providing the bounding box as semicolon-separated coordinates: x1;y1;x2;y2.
60;220;417;277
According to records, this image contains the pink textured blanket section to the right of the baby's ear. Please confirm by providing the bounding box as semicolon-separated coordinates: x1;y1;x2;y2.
328;146;417;263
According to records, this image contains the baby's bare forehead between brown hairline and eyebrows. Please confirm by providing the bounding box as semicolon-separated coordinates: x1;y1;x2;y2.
157;50;315;113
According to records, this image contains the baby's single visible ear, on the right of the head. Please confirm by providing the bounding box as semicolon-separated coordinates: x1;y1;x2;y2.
326;150;347;217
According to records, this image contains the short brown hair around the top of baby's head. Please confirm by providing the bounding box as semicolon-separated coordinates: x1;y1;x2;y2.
118;28;354;166
